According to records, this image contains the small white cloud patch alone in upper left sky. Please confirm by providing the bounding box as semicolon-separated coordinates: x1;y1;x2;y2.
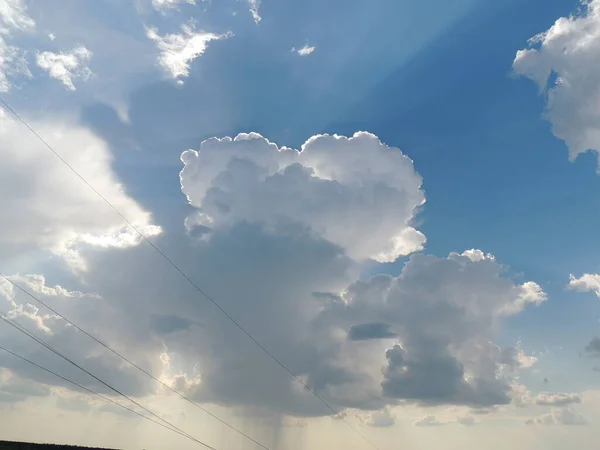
36;46;92;91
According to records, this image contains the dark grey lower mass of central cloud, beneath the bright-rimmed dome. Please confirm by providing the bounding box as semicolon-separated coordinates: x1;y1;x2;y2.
71;237;544;417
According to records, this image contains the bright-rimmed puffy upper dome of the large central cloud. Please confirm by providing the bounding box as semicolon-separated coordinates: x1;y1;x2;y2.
180;133;425;262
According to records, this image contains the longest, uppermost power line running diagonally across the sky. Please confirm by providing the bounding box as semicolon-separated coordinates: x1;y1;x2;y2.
0;98;379;450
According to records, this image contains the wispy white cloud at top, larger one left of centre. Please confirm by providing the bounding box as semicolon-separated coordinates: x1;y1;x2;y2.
146;25;233;78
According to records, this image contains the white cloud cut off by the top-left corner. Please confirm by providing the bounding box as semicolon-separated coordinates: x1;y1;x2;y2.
0;0;35;92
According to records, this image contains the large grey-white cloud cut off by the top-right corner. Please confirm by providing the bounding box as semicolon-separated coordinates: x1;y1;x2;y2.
513;0;600;168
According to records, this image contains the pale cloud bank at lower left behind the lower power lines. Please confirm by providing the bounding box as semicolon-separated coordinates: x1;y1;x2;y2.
0;275;159;401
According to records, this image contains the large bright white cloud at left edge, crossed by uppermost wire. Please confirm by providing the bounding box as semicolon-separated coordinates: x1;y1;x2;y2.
0;111;160;264
